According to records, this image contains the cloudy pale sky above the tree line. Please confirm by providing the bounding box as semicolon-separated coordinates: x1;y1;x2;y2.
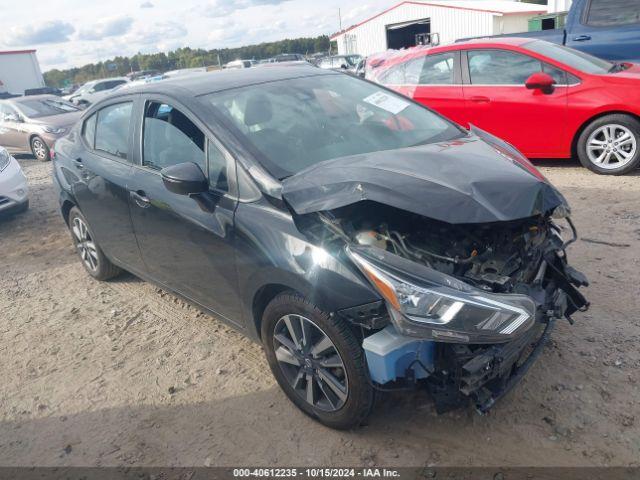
0;0;394;72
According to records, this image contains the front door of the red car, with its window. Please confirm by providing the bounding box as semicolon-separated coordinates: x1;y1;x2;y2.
462;49;568;157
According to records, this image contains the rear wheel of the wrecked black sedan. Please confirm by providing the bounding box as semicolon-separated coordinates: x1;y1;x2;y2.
69;207;122;280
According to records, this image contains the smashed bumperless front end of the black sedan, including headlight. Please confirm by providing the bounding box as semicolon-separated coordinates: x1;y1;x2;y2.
298;201;588;412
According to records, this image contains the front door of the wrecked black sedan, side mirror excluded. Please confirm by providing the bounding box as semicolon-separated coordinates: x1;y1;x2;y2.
130;96;241;323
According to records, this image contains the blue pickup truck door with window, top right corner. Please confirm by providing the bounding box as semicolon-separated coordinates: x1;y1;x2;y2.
566;0;640;62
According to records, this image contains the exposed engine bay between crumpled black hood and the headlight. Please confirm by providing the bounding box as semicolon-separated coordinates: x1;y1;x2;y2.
316;202;562;293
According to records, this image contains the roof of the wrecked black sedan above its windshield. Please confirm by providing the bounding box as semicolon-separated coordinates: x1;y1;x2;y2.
110;64;339;98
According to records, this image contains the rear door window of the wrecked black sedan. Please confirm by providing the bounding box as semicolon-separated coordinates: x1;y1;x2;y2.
95;102;133;159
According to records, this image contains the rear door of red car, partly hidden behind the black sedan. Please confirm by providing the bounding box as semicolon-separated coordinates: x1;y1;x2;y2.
380;52;466;126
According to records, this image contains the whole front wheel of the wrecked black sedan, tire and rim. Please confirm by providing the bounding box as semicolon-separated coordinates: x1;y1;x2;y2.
262;292;375;429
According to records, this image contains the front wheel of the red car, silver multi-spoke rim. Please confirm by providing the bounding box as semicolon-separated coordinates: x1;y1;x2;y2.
577;114;640;175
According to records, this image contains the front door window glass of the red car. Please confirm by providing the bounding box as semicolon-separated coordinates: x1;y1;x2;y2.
467;50;542;85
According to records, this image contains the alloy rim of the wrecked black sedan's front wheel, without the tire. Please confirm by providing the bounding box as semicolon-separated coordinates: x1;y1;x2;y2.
273;314;349;412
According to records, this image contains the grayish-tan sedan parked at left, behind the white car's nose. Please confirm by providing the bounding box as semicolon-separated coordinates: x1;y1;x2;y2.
0;95;82;162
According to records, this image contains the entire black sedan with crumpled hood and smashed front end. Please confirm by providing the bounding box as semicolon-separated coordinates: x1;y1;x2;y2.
53;66;588;428
